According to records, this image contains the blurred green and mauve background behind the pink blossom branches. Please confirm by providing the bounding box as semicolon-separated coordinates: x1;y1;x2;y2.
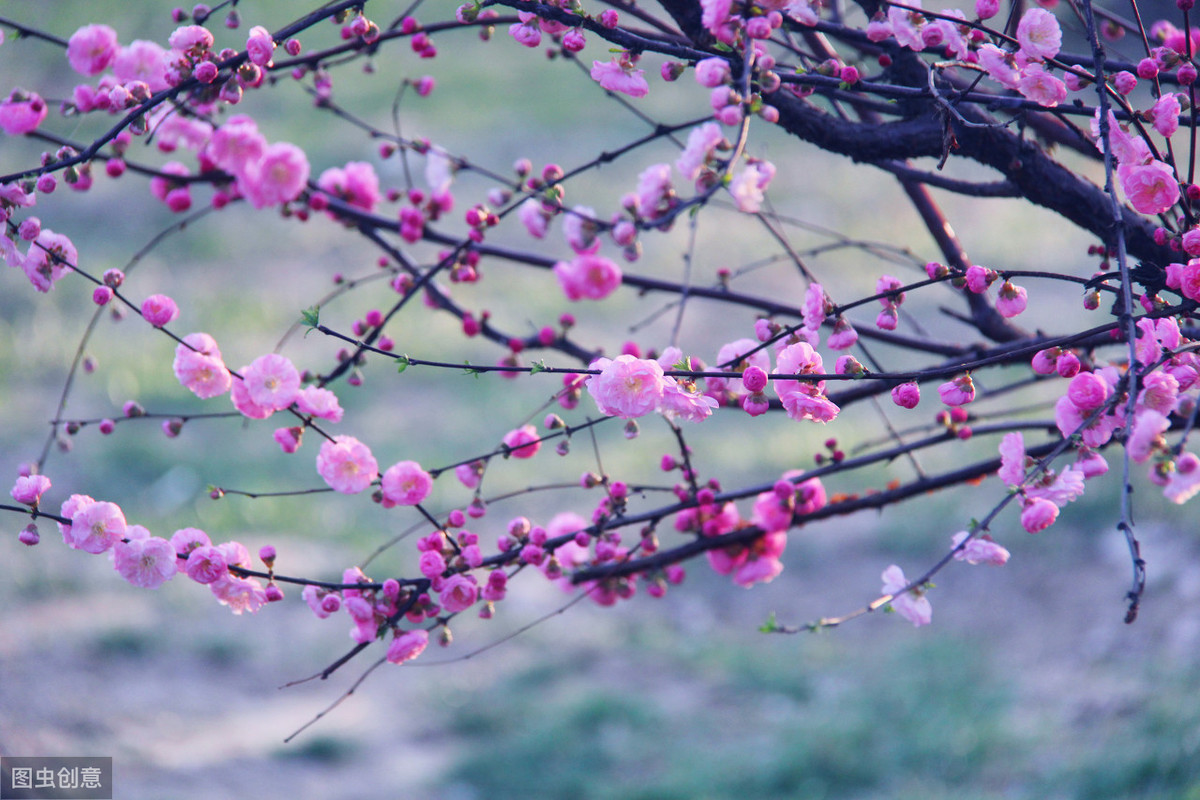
0;0;1200;800
